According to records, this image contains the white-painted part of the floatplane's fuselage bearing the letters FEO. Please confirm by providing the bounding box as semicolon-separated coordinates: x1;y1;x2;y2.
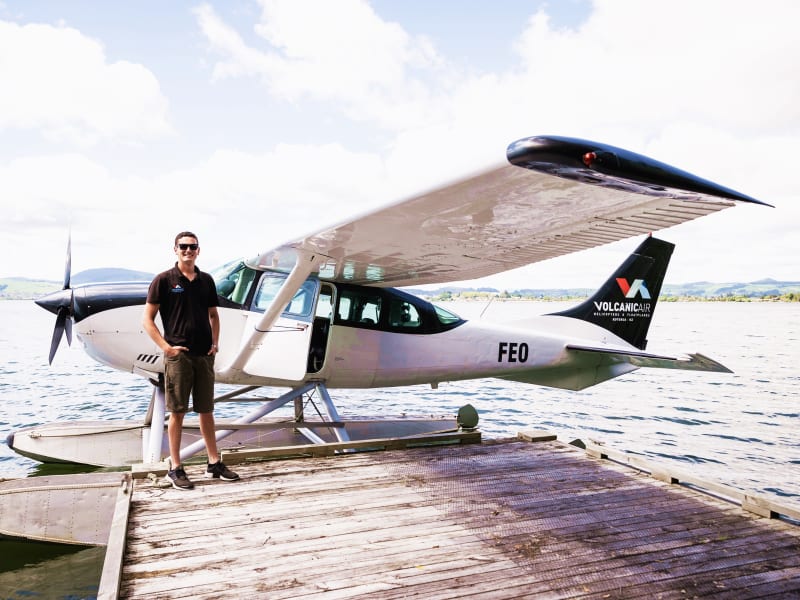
74;288;636;389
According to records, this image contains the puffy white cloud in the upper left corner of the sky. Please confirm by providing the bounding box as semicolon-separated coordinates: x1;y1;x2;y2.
0;21;170;146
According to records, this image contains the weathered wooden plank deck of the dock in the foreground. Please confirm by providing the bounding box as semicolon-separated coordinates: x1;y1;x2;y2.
121;440;800;600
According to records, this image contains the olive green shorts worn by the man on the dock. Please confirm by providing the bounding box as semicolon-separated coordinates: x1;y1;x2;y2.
164;352;214;413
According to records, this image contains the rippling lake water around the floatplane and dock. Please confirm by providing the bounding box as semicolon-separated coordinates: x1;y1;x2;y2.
0;301;800;598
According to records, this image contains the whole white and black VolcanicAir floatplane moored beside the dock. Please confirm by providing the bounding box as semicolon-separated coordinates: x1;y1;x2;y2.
8;136;765;466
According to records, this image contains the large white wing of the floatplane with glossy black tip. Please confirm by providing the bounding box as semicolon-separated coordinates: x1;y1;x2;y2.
257;136;765;287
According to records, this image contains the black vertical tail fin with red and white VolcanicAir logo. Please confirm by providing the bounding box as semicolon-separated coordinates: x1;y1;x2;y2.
552;237;675;350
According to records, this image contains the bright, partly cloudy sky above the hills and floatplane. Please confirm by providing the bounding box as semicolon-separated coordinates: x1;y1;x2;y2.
0;0;800;289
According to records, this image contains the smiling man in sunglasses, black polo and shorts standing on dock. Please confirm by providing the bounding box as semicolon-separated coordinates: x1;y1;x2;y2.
142;231;239;490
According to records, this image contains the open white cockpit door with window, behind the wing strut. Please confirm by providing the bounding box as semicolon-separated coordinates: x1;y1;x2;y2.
245;271;320;381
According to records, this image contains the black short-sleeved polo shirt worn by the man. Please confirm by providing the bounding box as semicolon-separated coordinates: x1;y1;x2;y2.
147;263;219;356
